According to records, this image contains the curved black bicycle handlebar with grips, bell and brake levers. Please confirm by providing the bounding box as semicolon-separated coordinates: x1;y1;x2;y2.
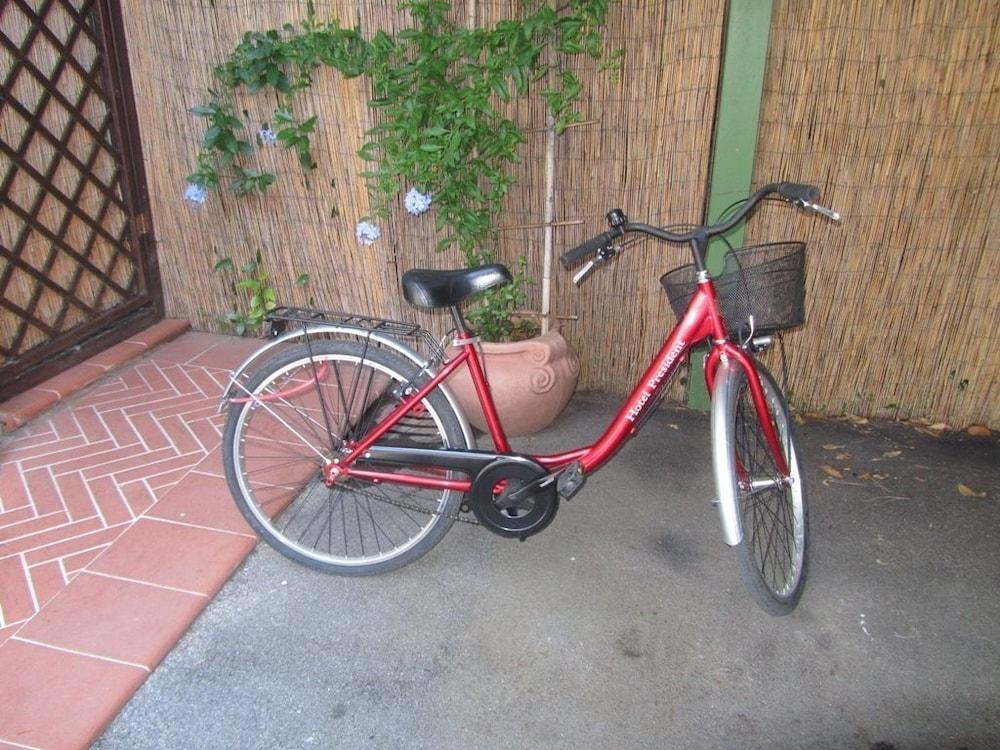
559;182;840;278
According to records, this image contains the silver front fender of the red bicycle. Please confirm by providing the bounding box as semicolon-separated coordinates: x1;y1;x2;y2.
712;356;743;547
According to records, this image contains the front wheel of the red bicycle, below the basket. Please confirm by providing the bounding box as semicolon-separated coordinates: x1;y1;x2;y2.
727;363;809;615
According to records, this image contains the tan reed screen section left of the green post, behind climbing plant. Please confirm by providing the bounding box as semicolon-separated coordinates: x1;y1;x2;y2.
124;0;722;400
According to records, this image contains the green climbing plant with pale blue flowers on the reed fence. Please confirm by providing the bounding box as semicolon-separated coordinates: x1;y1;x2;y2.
188;0;622;338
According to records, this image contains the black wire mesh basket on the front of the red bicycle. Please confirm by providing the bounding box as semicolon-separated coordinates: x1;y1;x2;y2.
660;242;806;336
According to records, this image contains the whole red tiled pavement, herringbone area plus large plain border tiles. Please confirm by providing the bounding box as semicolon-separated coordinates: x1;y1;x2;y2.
0;333;258;748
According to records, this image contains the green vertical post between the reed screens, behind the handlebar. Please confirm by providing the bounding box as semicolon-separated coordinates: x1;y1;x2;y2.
688;0;772;409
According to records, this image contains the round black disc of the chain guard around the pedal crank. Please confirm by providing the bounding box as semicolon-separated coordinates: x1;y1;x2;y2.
469;457;559;540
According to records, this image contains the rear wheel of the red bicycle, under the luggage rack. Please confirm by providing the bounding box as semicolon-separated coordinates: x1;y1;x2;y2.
223;340;468;575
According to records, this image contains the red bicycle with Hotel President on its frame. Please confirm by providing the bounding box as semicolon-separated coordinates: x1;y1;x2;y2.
223;183;839;614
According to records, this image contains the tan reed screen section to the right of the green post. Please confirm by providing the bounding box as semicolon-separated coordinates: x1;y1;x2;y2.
750;0;1000;428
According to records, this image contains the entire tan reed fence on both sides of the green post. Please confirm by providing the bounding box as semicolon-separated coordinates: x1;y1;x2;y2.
124;0;1000;426
